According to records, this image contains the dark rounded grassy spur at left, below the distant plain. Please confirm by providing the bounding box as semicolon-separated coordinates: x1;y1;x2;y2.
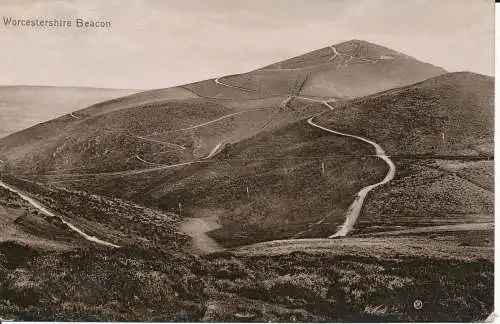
0;99;233;173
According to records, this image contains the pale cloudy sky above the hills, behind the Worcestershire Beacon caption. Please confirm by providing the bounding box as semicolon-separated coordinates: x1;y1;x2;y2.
0;0;494;89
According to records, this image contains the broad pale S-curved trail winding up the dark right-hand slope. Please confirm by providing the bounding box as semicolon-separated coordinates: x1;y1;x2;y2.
307;117;396;238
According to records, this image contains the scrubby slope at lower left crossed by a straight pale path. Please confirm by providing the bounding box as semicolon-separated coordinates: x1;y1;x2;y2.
0;176;187;250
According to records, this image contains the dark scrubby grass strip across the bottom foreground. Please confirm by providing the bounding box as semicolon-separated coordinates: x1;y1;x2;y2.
0;242;493;321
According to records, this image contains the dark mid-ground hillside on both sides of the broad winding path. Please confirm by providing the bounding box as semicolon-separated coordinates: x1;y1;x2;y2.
46;73;493;246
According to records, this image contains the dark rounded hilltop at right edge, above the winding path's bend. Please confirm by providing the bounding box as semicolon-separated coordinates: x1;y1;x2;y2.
317;72;494;156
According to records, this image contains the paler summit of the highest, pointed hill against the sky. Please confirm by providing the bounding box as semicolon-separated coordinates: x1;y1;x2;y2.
191;40;446;99
